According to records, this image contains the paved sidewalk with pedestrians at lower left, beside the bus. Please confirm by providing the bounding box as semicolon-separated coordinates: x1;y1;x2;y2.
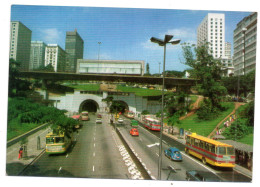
6;127;50;176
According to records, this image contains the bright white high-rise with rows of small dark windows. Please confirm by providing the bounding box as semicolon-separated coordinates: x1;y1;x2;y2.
197;13;225;58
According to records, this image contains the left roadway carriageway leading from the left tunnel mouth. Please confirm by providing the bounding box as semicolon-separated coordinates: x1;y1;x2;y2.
22;115;131;179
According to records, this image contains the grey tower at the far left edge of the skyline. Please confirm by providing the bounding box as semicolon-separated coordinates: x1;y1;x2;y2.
9;21;32;71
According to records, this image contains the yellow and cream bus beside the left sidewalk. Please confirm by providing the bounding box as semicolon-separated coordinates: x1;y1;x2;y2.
46;132;72;154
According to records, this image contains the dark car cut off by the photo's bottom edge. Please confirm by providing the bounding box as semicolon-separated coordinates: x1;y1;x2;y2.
186;170;222;182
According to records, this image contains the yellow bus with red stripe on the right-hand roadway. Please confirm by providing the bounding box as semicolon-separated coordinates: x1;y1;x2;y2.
185;133;235;168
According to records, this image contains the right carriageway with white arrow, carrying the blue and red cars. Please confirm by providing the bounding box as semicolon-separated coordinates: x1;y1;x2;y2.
120;116;251;182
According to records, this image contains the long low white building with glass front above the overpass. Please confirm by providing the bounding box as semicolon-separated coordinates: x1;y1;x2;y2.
77;59;144;75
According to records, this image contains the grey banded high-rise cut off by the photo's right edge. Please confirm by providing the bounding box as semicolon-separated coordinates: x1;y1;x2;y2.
233;12;257;75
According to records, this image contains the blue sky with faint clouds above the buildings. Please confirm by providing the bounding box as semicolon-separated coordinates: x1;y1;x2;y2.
10;5;251;74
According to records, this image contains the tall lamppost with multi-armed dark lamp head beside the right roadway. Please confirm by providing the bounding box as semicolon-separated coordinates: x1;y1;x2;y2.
150;35;181;180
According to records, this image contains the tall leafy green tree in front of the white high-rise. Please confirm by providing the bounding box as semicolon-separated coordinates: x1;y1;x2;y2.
182;44;227;119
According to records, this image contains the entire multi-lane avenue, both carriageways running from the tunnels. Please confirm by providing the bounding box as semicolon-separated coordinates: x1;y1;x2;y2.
22;114;251;182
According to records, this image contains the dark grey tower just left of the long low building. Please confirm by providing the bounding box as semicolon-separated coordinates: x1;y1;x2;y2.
65;29;84;72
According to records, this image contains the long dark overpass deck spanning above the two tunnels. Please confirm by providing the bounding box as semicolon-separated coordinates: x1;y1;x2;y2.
18;71;197;89
